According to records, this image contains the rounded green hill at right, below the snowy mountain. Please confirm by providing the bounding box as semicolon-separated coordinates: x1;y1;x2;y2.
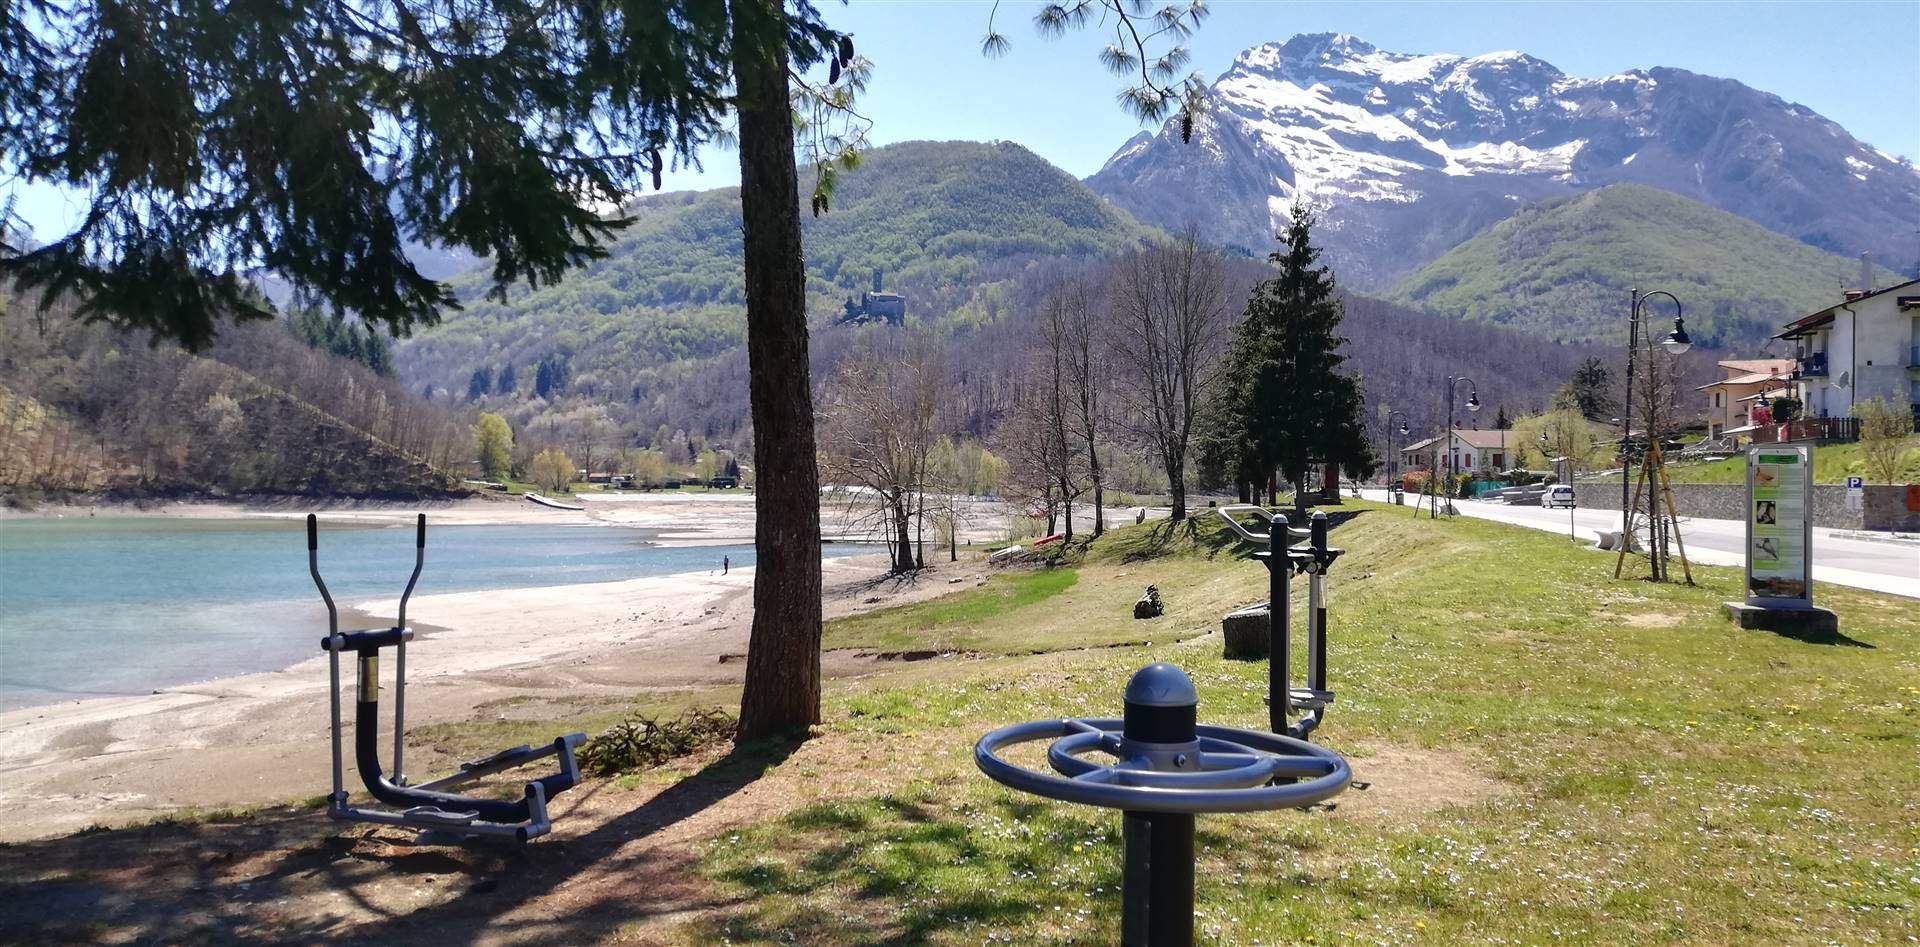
1390;184;1899;344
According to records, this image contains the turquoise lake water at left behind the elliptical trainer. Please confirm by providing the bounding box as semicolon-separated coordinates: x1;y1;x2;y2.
0;517;872;709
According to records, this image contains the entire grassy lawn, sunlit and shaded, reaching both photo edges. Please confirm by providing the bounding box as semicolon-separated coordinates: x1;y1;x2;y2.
0;503;1920;945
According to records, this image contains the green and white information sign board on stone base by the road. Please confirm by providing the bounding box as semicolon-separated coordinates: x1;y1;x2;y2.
1726;444;1839;636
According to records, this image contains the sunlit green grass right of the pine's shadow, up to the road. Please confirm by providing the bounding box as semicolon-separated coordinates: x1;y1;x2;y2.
680;507;1920;945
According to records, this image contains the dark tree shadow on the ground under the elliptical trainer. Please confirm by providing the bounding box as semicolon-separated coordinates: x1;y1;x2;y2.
0;740;799;943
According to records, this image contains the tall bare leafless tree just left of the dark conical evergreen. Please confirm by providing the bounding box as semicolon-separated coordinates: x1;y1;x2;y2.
1108;227;1231;521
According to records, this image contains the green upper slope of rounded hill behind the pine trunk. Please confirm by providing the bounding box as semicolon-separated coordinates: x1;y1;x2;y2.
396;142;1150;403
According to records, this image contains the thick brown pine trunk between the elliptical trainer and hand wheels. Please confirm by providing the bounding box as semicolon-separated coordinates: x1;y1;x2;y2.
732;0;820;740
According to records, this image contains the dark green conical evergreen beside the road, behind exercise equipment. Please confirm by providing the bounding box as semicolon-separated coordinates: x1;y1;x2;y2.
1202;204;1375;511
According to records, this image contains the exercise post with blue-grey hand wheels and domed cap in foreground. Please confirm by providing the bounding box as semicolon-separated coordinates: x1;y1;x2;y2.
973;665;1352;947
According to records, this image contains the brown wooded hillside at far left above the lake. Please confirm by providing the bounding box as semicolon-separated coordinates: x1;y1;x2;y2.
0;294;472;501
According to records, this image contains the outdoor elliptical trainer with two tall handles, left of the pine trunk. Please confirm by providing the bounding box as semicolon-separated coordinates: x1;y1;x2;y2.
307;513;586;841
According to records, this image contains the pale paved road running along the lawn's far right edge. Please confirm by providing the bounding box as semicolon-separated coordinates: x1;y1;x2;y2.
1361;490;1920;599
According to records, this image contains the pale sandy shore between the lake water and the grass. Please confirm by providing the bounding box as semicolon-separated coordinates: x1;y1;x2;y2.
0;555;987;841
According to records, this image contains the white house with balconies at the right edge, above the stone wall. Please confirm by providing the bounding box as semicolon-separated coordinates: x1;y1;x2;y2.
1774;280;1920;419
